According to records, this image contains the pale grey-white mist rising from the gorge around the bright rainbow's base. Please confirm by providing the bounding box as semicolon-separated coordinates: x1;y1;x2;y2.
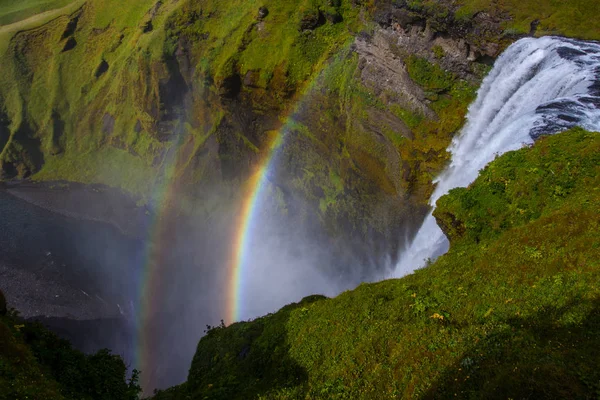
137;176;377;393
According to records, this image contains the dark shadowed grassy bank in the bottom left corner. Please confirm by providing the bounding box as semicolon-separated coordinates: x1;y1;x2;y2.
0;302;140;400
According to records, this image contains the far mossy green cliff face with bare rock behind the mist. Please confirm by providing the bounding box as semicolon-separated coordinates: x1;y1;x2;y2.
0;0;596;268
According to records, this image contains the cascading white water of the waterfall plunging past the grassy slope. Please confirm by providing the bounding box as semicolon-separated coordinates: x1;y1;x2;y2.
394;37;600;277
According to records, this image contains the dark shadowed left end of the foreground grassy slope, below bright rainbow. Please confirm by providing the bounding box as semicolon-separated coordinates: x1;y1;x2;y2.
185;296;325;400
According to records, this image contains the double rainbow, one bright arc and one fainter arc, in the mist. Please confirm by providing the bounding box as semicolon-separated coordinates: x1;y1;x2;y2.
134;45;342;388
